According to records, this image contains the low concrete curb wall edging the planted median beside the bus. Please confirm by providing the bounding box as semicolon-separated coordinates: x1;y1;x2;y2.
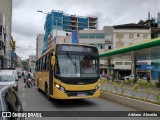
100;91;160;111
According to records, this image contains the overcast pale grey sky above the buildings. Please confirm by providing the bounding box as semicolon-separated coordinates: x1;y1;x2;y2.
12;0;160;59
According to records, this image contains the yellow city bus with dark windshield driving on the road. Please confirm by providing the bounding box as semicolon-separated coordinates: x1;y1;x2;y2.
35;44;100;99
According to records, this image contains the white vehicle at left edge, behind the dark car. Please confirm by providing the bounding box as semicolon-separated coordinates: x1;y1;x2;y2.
0;70;18;91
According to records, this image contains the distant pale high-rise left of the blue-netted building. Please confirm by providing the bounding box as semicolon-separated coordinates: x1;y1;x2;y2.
36;34;44;58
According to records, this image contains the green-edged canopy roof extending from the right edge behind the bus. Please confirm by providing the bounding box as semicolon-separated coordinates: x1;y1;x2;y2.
100;37;160;61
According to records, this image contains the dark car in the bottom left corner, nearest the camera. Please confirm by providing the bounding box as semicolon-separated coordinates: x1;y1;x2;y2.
0;85;25;120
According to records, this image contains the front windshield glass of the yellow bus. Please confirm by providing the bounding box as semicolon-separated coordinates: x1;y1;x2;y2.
55;52;98;77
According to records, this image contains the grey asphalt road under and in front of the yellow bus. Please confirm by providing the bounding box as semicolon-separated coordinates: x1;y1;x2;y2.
17;78;159;120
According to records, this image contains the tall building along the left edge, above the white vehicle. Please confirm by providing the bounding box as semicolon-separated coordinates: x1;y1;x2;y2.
0;0;14;69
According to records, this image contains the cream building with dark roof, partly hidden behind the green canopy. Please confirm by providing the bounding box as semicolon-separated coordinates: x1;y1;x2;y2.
112;24;151;76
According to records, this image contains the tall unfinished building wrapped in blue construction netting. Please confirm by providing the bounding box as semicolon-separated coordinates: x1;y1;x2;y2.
43;10;98;52
